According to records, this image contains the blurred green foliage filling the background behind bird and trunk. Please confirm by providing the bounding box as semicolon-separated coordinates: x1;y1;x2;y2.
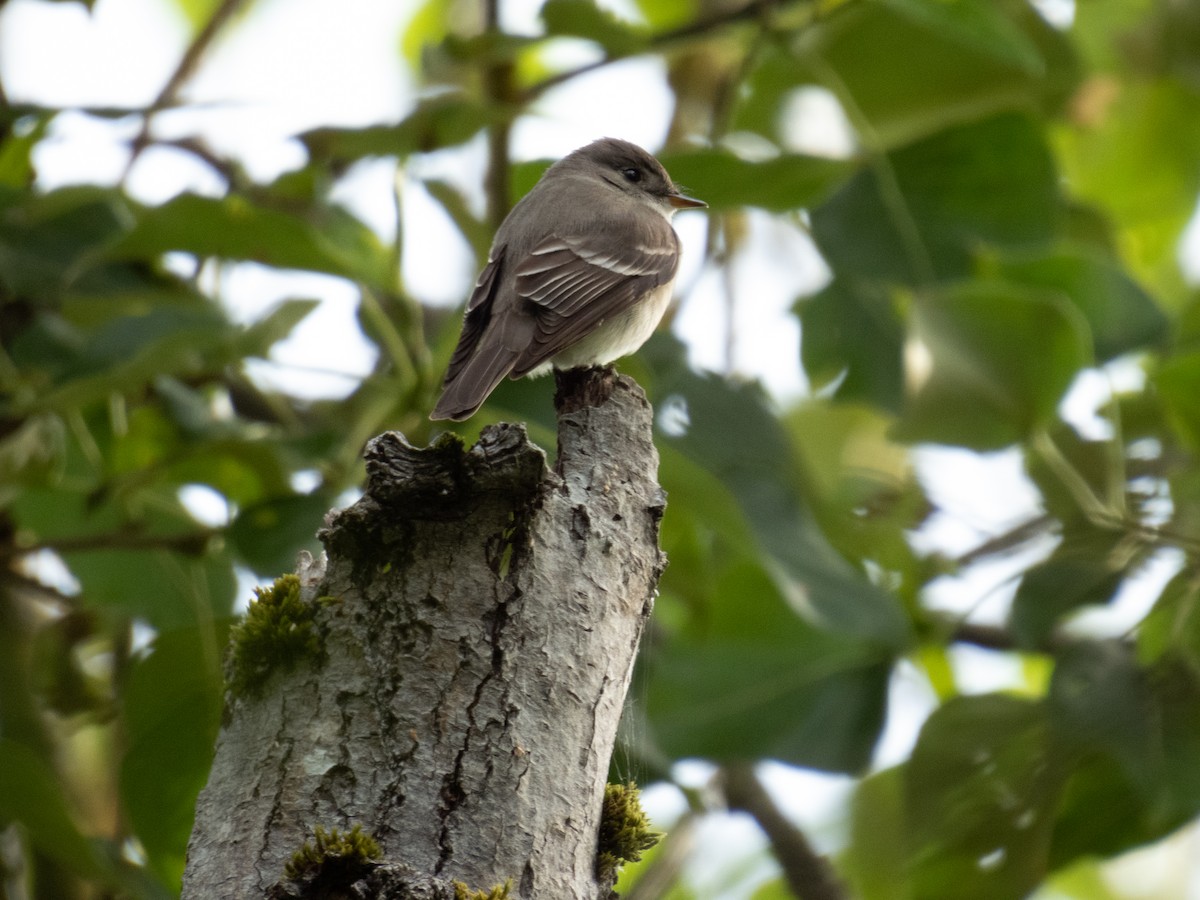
0;0;1200;900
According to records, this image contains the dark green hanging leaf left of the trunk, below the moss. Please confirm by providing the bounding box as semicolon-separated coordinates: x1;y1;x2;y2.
120;629;224;890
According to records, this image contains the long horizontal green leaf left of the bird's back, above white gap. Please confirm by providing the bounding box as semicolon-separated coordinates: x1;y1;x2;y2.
108;194;389;286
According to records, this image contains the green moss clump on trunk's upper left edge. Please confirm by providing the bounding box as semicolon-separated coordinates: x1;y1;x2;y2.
227;575;324;697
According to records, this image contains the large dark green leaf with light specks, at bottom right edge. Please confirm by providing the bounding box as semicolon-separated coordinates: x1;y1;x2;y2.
905;695;1062;900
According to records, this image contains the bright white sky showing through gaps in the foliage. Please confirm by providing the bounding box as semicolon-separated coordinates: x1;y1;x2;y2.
0;0;1200;899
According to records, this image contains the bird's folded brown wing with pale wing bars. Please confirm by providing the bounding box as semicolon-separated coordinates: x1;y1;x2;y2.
512;230;679;378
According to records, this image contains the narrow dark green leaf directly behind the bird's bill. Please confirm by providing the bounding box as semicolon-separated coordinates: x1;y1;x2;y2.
659;150;856;212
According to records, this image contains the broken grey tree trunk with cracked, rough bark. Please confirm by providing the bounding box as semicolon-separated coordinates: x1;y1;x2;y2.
184;372;665;900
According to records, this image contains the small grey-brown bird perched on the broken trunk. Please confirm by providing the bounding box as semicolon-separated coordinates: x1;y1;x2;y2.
430;138;708;421
